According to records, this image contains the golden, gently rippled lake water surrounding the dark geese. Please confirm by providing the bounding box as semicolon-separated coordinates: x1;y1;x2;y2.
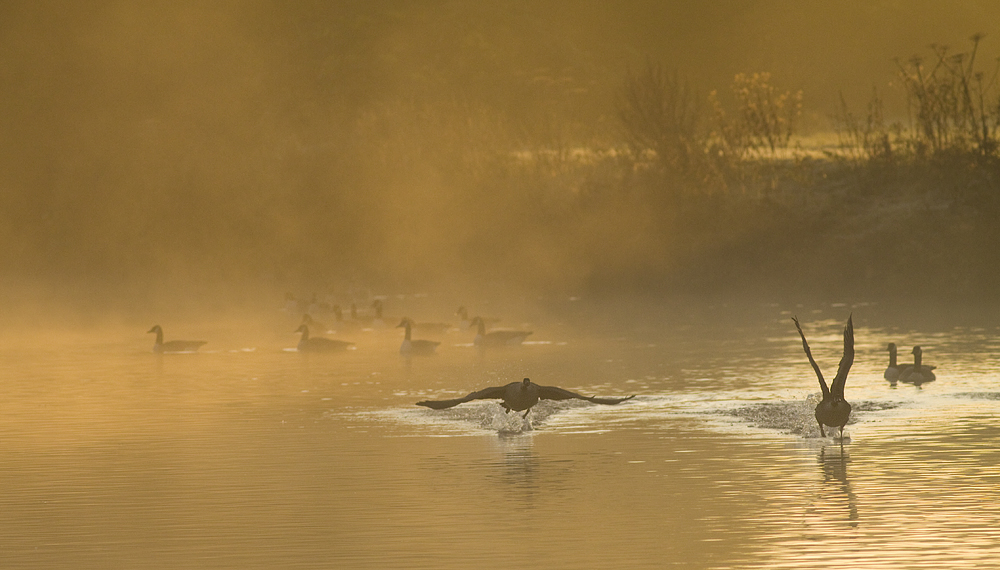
0;300;1000;569
